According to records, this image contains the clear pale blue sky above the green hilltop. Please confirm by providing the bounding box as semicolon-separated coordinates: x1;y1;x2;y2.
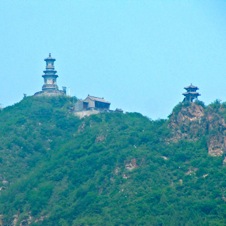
0;0;226;119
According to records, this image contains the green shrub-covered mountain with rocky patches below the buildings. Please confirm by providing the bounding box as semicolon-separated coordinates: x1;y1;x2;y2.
0;96;226;226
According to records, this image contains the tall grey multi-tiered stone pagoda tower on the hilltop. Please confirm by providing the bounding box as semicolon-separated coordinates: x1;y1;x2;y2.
34;53;66;96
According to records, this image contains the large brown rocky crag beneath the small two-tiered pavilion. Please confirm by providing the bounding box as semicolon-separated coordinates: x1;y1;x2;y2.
169;103;226;156
